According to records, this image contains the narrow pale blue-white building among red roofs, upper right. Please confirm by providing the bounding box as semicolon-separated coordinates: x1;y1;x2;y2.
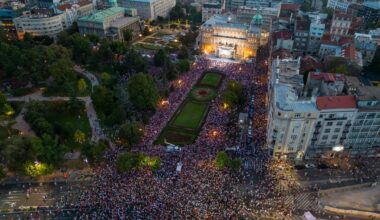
307;17;325;54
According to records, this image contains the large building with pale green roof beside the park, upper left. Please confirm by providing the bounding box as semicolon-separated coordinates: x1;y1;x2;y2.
78;7;141;40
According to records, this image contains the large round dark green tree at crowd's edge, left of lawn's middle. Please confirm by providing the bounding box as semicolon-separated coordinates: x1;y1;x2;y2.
127;73;159;111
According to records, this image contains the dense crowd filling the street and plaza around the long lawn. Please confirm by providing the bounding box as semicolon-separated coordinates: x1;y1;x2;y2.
75;46;308;219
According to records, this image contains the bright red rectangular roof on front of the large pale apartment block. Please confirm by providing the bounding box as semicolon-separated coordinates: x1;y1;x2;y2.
317;96;356;110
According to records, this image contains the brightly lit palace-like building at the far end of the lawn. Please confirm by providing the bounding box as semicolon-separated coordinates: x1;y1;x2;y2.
197;11;269;59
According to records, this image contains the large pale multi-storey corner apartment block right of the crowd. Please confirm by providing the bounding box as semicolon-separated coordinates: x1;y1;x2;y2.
267;57;380;160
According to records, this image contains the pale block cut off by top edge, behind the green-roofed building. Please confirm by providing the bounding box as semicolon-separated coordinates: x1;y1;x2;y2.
119;0;176;19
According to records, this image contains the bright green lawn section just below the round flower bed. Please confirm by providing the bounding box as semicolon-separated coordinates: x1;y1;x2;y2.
172;101;208;129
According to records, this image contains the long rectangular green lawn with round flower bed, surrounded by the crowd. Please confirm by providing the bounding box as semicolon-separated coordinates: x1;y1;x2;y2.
155;73;223;145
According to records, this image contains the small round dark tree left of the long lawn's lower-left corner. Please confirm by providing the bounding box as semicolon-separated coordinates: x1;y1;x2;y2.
119;121;144;146
